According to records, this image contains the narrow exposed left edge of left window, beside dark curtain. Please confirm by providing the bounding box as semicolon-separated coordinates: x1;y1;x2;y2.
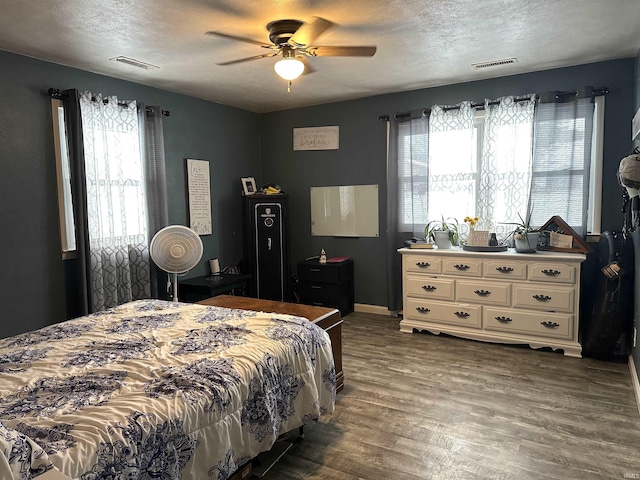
51;98;76;259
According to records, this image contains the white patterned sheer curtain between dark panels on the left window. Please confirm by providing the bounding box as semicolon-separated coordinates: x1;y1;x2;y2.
80;92;150;311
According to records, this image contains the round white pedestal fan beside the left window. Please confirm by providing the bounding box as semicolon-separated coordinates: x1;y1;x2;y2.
149;225;202;302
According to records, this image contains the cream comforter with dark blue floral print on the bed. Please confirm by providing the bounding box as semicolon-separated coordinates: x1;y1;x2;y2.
0;300;335;480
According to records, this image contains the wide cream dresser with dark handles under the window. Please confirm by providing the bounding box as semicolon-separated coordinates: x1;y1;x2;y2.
398;248;586;357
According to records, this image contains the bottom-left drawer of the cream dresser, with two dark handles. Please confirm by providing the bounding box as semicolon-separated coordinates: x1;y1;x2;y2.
403;298;482;328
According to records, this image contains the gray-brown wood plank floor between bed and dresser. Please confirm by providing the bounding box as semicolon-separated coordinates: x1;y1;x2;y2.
264;313;640;480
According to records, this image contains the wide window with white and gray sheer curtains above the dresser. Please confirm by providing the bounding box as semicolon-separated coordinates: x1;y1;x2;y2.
396;96;604;235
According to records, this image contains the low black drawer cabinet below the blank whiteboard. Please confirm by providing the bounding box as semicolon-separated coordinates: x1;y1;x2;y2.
298;259;354;316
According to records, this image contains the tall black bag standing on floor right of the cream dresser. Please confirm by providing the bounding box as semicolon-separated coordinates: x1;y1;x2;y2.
582;232;635;358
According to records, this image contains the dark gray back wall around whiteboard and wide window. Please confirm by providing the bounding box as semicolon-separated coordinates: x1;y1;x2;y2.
260;58;634;306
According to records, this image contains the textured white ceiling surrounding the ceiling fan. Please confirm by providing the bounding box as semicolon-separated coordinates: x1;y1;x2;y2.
0;0;640;112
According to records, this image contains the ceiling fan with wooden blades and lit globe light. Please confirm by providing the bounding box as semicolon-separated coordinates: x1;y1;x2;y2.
207;17;377;91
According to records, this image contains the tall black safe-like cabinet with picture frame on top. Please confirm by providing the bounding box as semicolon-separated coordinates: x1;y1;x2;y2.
243;193;291;302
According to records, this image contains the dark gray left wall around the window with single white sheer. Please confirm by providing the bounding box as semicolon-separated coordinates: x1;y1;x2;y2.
0;51;260;337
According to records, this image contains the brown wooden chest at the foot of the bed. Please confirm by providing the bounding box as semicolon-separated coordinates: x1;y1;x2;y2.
196;295;344;392
